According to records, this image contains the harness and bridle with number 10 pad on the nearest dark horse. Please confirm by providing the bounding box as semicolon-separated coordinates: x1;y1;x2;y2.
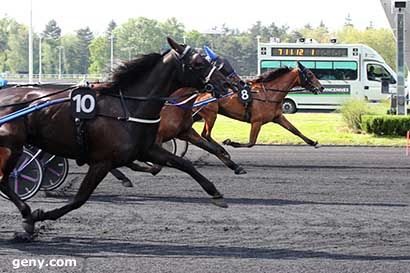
0;46;227;165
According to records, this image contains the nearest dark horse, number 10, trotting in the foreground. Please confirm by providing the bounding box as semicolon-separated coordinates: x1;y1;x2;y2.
0;38;229;240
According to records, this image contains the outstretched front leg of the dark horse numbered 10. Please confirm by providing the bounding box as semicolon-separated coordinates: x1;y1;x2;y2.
144;144;228;208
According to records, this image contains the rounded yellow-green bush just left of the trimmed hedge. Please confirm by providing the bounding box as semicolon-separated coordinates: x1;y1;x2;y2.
340;99;369;131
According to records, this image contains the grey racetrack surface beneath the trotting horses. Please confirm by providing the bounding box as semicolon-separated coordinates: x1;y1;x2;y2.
0;146;410;273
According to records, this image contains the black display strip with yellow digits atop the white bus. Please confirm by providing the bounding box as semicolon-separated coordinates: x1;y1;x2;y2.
271;47;348;57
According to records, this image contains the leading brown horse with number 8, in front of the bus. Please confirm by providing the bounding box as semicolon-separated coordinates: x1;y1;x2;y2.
197;62;324;148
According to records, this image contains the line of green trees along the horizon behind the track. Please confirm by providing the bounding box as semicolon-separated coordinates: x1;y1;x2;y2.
0;17;396;75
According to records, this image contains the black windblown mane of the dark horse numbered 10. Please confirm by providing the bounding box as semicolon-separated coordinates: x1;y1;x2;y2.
111;53;163;87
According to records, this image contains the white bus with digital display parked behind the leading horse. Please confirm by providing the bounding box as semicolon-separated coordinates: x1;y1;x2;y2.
258;40;397;113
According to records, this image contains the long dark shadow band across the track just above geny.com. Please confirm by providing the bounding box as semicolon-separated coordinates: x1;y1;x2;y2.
0;237;410;261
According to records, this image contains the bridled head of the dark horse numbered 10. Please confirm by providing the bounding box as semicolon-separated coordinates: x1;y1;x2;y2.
167;37;232;97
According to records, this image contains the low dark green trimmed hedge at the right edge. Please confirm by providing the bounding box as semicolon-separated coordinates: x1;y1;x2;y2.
362;115;410;136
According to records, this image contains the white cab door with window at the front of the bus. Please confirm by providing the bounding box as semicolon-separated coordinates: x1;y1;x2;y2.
363;62;396;102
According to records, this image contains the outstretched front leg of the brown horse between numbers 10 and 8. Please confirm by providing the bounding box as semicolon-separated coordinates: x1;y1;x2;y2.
180;128;246;174
